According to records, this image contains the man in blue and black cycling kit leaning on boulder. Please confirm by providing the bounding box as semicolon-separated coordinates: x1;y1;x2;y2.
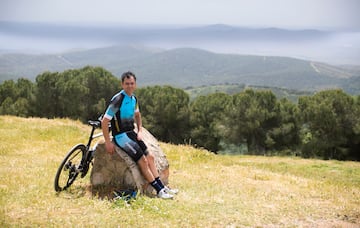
101;71;177;199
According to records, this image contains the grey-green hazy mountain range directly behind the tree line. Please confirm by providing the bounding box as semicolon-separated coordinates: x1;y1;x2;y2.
0;46;360;93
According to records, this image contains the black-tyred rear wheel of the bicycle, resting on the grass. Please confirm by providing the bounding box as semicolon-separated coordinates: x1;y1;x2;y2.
54;144;86;192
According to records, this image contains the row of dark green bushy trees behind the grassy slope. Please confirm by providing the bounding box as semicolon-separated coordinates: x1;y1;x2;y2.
0;66;360;161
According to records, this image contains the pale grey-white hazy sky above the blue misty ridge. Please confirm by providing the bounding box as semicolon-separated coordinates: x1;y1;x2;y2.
0;0;360;31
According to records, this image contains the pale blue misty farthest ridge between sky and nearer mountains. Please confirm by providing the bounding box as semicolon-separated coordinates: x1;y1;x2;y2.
0;21;360;65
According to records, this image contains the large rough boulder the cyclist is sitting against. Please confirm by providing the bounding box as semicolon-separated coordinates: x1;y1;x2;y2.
90;128;169;197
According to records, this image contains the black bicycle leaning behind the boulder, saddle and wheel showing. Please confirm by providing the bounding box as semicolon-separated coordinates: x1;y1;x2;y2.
54;117;103;192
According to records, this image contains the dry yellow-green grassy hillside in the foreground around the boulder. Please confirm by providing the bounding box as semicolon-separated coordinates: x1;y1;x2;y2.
0;116;360;227
